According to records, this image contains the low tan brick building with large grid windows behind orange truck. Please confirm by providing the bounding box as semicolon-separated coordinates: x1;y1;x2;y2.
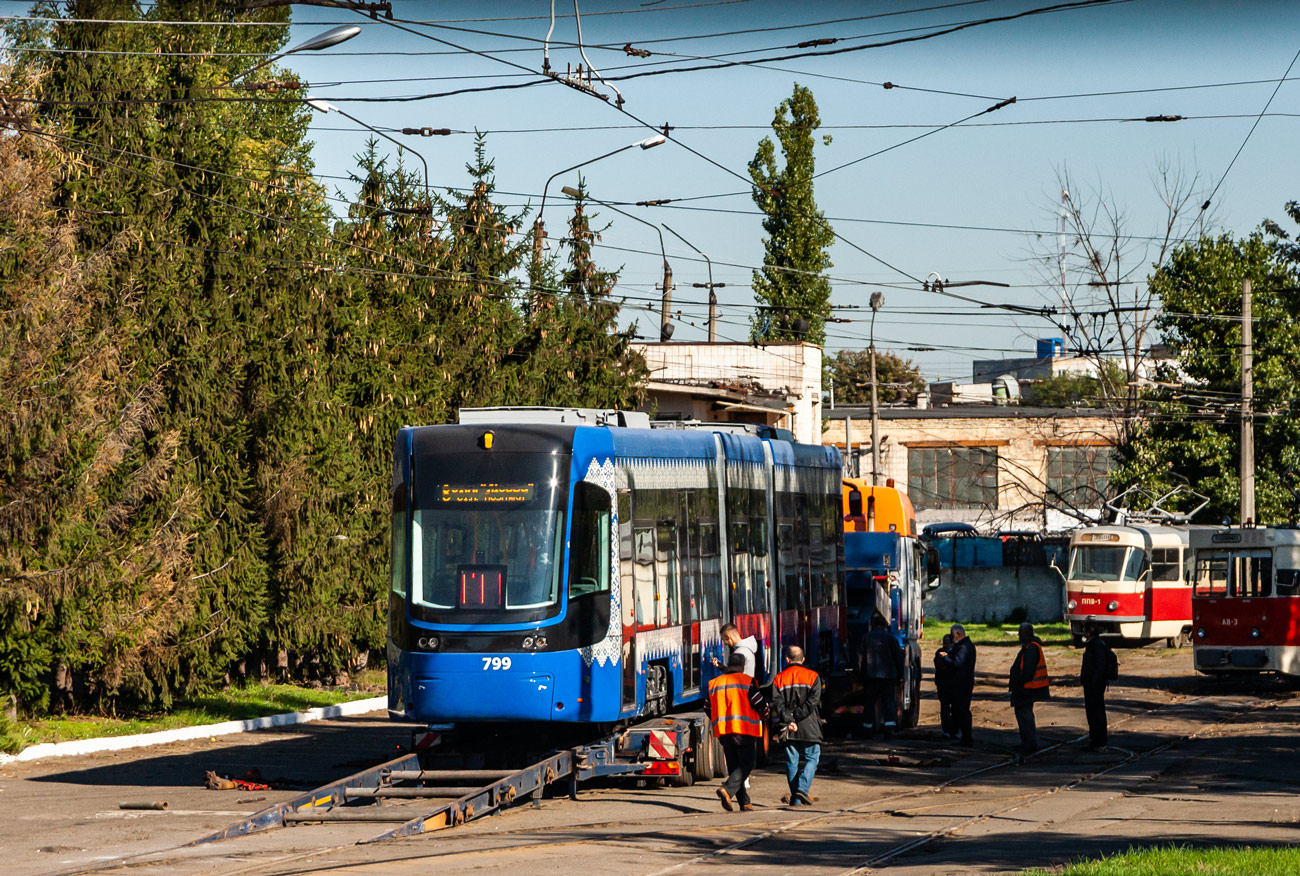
823;404;1118;533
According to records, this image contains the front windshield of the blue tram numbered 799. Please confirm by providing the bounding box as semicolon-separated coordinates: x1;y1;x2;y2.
411;452;569;624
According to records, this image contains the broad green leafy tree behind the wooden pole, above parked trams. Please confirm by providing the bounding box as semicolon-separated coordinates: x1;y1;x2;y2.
1117;225;1300;521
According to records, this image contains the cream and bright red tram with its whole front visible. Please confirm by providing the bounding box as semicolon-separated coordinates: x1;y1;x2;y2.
1065;522;1196;647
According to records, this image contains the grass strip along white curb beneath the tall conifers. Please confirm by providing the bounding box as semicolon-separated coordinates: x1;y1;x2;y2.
0;672;384;754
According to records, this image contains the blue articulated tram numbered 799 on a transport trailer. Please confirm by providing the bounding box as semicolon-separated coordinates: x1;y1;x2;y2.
387;408;846;724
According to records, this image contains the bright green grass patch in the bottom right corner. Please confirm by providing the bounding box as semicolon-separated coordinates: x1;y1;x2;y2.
1024;846;1300;876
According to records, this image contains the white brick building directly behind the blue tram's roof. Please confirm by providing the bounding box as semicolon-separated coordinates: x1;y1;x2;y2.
633;342;822;444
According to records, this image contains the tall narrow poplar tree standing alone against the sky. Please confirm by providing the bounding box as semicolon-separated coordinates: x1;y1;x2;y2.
749;83;835;344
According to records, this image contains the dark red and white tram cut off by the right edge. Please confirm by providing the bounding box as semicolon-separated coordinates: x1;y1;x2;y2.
1191;526;1300;676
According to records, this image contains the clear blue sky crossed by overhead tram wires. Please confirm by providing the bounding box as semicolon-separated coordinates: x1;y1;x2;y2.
276;0;1300;380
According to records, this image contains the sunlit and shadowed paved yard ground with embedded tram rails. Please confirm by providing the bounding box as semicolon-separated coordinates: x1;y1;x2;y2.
0;636;1300;876
